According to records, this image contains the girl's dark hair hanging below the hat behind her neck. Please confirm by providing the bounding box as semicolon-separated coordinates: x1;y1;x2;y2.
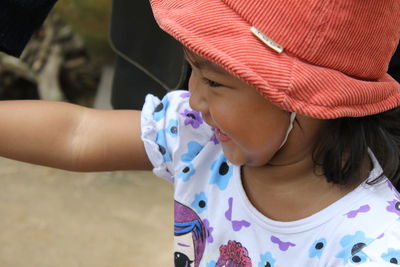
313;107;400;189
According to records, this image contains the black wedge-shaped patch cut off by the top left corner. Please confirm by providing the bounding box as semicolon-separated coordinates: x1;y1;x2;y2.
0;0;57;57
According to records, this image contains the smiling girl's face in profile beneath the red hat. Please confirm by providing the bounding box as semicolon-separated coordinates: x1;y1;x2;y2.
185;51;289;166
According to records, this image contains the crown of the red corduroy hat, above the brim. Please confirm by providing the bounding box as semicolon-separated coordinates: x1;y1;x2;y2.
222;0;400;80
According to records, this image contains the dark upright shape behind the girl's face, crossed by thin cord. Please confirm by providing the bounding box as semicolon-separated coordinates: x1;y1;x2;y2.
110;0;188;109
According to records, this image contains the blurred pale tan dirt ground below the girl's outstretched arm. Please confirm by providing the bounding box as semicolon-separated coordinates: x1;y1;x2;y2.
0;158;173;267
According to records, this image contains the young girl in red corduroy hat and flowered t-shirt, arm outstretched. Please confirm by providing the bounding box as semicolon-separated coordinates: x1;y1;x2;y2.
0;0;400;267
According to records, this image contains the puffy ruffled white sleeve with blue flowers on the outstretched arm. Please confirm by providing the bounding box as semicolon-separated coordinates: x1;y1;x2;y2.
141;90;213;183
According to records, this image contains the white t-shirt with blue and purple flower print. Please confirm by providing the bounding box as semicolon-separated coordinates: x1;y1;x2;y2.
142;91;400;267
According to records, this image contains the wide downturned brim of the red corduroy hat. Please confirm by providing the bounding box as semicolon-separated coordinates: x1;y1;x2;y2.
151;0;400;119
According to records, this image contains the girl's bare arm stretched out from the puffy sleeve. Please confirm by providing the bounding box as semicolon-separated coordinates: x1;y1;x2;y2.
0;100;151;171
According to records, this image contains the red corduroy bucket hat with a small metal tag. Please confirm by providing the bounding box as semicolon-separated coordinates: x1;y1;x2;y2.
151;0;400;119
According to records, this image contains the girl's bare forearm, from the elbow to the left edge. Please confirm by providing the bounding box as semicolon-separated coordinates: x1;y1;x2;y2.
0;101;86;169
